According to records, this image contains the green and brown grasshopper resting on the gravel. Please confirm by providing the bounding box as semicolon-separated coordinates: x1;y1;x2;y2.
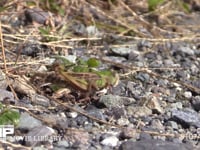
52;56;119;94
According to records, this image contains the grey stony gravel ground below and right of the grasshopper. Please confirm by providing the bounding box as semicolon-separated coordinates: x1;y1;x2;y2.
0;1;200;150
